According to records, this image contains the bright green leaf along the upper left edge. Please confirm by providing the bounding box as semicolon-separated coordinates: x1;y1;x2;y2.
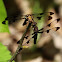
0;0;9;33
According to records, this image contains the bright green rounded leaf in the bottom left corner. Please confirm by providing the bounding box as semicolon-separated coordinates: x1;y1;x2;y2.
0;43;11;62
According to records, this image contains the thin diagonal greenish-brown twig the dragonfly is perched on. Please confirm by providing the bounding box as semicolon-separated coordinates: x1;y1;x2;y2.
8;21;31;62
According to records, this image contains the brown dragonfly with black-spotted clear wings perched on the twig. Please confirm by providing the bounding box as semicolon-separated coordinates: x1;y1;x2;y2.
2;12;60;48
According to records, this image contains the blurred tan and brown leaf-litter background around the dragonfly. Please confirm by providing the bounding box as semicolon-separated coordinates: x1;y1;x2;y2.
0;0;62;62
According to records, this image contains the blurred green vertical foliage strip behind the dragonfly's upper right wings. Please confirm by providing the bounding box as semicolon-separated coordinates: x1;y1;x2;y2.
33;0;45;40
